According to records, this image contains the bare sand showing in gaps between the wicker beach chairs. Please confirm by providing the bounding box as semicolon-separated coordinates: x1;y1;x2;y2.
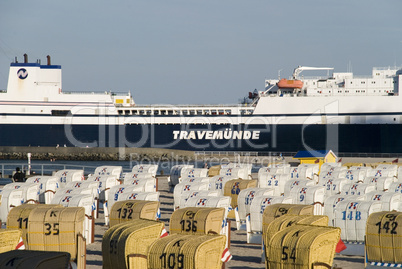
87;177;364;269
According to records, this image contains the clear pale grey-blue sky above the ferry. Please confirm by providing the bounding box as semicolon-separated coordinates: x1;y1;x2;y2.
0;0;402;104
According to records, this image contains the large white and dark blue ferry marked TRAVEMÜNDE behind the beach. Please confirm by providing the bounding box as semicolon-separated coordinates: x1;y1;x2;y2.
0;55;402;154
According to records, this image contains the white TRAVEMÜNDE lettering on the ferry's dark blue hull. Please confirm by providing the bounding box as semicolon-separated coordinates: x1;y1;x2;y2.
173;129;260;140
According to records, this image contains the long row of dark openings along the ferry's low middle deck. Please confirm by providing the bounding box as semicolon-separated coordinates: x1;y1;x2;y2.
118;109;253;116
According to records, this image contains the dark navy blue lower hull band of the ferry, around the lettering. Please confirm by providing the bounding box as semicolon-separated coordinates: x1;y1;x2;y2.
0;124;402;153
